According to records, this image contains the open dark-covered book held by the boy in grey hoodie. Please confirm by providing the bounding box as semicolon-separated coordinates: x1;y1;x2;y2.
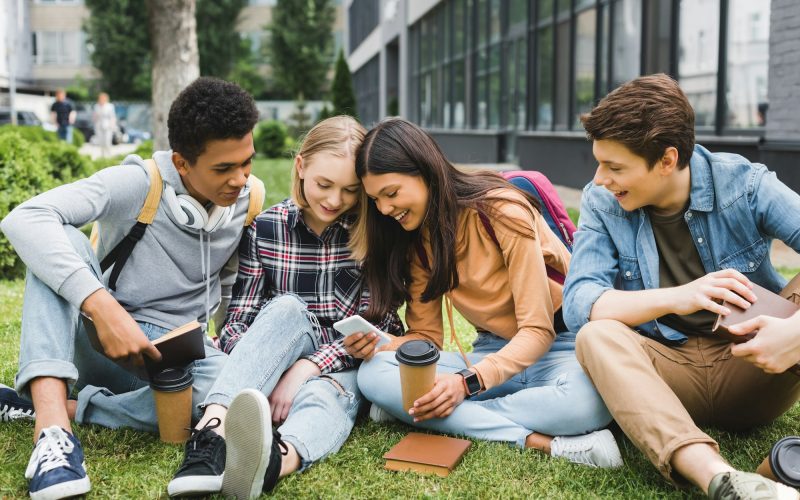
81;314;206;381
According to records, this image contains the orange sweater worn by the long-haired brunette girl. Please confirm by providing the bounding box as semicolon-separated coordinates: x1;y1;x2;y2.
388;189;570;389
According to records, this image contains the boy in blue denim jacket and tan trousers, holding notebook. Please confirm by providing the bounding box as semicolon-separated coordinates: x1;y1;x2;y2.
564;74;800;498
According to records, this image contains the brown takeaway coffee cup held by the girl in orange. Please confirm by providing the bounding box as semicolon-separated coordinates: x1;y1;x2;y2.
395;340;439;412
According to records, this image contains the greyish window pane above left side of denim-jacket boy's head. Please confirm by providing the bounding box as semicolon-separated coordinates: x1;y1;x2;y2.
611;0;642;88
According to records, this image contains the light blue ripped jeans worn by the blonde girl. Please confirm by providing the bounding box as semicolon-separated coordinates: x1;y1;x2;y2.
203;295;361;471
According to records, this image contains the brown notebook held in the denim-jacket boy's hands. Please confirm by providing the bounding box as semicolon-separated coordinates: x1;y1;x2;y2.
711;283;800;375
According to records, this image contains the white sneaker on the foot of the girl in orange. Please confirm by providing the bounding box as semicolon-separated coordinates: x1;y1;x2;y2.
550;429;623;468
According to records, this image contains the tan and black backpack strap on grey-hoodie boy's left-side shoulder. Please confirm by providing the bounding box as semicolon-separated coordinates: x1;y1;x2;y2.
97;159;164;290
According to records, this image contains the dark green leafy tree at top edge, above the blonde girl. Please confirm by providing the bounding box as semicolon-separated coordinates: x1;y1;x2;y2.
268;0;336;99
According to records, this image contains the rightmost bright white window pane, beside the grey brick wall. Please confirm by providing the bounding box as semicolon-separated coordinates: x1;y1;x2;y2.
725;0;770;128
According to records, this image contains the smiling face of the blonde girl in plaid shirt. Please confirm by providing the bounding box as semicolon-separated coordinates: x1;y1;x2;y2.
295;152;361;234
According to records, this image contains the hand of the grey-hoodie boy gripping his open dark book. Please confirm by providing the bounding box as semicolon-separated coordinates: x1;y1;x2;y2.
81;288;161;366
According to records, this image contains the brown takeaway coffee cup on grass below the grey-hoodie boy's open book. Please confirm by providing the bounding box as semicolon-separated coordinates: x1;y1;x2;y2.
150;368;192;443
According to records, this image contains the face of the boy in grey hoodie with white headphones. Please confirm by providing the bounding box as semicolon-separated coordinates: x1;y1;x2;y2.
172;133;256;207
